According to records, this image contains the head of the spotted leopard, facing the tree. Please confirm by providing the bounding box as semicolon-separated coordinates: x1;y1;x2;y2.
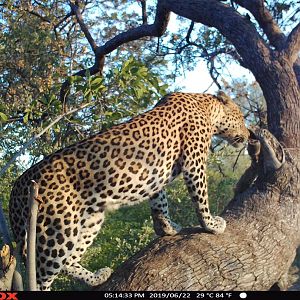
215;94;250;148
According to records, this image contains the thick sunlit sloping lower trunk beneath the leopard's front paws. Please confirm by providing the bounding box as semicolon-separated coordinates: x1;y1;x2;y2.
100;131;300;291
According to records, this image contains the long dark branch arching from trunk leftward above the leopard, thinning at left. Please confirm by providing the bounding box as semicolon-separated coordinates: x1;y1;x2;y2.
60;0;271;110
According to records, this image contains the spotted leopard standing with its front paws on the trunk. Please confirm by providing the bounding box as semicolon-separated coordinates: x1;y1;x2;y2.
9;92;249;290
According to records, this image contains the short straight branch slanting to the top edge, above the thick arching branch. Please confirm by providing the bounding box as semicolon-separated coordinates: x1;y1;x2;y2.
234;0;286;50
